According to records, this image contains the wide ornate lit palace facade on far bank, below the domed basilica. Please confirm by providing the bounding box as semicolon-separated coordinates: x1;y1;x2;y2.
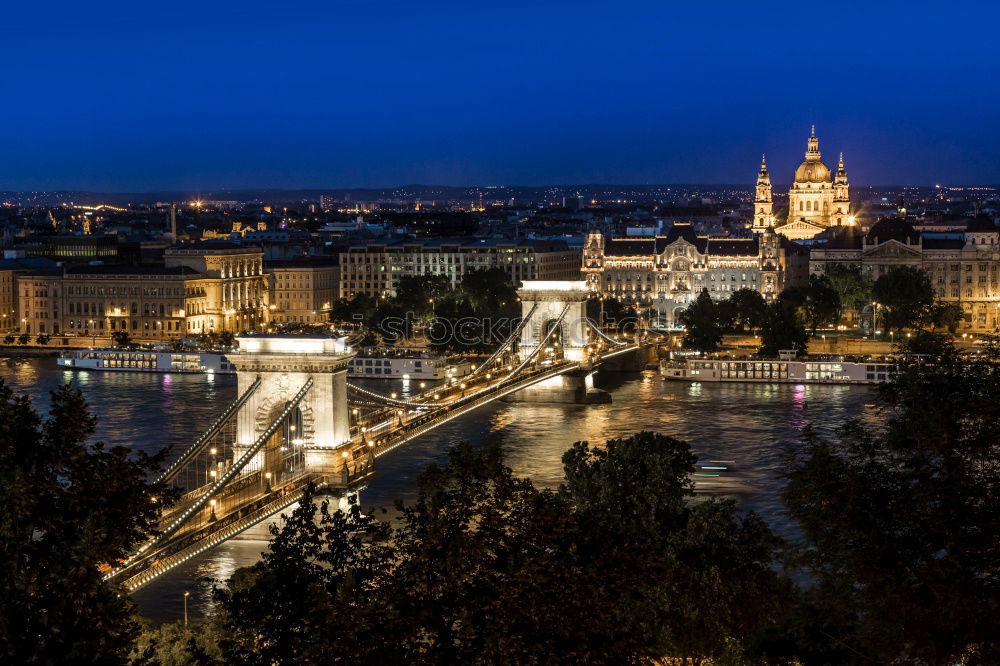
583;222;809;326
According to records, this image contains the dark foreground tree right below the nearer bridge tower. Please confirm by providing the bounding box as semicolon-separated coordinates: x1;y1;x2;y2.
216;487;394;664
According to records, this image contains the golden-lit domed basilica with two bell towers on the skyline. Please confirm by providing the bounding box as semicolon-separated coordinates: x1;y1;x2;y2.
752;128;854;240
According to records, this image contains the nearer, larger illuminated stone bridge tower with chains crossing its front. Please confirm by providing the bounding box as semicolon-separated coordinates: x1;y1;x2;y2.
227;334;354;474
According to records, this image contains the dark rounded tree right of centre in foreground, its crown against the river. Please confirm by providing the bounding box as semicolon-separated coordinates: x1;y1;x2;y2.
562;432;792;664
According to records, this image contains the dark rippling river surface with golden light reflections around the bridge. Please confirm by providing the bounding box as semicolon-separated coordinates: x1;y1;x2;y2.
0;358;873;621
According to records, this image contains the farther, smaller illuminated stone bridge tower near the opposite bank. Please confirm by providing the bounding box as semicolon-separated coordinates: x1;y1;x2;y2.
517;280;590;361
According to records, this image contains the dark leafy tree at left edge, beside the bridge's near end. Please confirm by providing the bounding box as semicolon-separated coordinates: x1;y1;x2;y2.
0;381;174;664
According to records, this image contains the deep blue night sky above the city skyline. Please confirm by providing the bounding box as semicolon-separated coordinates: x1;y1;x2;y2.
0;0;1000;191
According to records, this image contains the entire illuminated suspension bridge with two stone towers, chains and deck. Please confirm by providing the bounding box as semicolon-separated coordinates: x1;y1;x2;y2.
106;281;658;591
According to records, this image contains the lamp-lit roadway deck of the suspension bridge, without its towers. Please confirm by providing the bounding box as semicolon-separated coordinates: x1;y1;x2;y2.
117;343;644;592
